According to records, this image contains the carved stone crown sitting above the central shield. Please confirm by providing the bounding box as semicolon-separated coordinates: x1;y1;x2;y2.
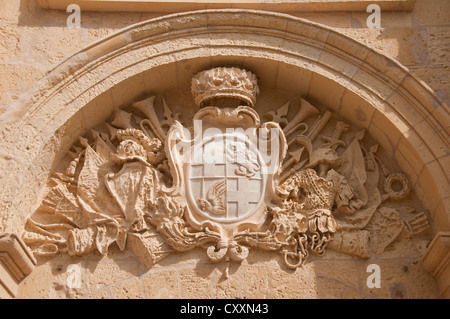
191;67;259;107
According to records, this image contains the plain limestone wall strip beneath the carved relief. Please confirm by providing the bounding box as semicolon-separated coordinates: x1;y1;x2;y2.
15;245;441;299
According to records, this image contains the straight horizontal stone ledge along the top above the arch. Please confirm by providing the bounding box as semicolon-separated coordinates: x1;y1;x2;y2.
38;0;416;13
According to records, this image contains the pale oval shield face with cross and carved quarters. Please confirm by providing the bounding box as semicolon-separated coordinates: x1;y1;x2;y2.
188;134;264;222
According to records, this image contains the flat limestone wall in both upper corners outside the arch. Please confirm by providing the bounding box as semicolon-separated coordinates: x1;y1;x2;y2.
0;0;450;119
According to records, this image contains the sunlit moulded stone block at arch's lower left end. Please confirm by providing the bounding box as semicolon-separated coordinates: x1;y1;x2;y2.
0;233;36;298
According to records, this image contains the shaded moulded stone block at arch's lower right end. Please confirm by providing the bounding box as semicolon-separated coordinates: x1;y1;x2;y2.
422;232;450;299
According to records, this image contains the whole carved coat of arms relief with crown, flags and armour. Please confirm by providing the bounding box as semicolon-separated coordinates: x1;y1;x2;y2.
23;68;429;268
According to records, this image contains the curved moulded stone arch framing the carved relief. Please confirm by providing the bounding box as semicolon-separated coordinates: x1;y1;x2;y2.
0;10;450;248
